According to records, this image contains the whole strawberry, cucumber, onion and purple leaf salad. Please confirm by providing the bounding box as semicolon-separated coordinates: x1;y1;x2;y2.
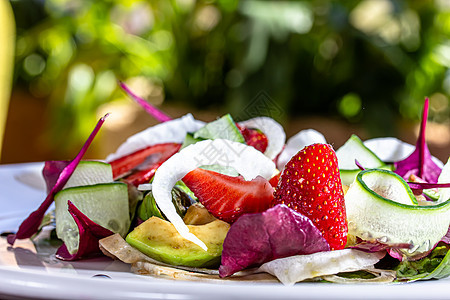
8;84;450;285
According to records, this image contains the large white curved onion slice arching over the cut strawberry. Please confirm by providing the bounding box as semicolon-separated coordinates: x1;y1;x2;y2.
152;139;276;250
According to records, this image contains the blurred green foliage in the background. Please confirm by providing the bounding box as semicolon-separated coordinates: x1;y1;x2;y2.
7;0;450;148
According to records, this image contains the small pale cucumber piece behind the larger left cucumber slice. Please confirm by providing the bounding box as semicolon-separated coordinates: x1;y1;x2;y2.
64;160;113;188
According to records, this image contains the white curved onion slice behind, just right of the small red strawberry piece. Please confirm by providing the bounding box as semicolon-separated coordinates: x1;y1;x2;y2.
239;117;286;159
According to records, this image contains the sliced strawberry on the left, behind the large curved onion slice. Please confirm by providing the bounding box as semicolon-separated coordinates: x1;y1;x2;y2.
110;143;181;186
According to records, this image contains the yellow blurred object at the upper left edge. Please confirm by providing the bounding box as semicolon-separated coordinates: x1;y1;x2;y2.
0;0;15;162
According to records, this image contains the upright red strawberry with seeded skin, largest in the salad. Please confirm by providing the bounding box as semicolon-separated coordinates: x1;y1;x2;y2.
273;144;348;250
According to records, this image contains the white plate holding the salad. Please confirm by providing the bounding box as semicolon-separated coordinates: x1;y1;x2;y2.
0;163;450;299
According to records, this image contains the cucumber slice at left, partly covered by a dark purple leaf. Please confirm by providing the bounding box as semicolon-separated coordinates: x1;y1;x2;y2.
55;182;130;254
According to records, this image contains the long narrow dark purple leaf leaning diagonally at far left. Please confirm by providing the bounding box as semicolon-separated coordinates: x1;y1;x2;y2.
7;114;109;245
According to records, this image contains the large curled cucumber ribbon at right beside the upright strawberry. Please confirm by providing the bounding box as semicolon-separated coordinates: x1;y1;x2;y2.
345;169;450;257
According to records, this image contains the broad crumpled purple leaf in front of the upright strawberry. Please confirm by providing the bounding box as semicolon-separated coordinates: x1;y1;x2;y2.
219;204;330;277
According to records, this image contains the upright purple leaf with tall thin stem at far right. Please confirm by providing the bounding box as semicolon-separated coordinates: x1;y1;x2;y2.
394;98;441;183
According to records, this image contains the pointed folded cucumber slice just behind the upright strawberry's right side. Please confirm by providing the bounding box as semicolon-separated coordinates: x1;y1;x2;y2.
336;134;386;185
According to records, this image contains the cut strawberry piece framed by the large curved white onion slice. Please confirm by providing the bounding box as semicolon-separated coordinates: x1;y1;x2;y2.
183;169;273;223
